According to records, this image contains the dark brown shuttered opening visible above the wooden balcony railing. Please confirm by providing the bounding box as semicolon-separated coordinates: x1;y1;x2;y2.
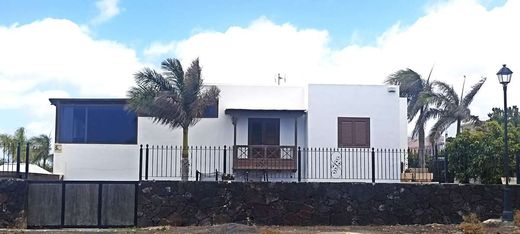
248;118;280;145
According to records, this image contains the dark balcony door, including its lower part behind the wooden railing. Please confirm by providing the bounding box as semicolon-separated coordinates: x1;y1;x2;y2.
248;118;280;158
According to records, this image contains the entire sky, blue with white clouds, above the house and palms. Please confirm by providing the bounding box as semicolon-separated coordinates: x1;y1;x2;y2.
0;0;520;135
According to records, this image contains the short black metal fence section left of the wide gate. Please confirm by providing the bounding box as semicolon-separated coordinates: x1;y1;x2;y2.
0;143;30;179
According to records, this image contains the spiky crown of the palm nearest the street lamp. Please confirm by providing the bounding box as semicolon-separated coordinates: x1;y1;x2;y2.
429;77;486;140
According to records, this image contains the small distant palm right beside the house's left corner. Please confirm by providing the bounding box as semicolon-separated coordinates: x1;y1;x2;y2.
29;134;54;170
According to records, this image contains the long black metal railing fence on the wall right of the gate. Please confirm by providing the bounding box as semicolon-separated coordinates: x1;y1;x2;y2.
139;145;448;183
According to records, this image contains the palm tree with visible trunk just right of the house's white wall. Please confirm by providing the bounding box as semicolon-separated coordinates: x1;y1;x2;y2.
385;67;437;167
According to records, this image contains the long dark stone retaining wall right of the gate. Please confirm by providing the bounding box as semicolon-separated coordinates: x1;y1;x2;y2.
137;181;520;226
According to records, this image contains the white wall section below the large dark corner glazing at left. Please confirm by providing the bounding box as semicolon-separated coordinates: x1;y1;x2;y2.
53;143;139;181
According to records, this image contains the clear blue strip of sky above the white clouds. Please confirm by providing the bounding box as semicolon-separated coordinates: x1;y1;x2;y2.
0;0;431;50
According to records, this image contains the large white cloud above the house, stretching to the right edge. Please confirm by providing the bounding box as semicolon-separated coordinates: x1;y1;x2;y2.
147;0;520;130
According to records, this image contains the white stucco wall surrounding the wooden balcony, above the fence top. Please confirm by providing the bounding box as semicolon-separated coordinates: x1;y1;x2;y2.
138;85;306;146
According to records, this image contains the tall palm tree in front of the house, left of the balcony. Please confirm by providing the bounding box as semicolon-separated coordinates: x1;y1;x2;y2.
128;58;220;181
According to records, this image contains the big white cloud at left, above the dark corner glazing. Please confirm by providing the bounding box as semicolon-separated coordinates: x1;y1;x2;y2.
0;19;143;136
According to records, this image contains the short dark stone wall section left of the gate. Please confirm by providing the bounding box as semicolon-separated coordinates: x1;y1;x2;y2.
0;179;27;228
